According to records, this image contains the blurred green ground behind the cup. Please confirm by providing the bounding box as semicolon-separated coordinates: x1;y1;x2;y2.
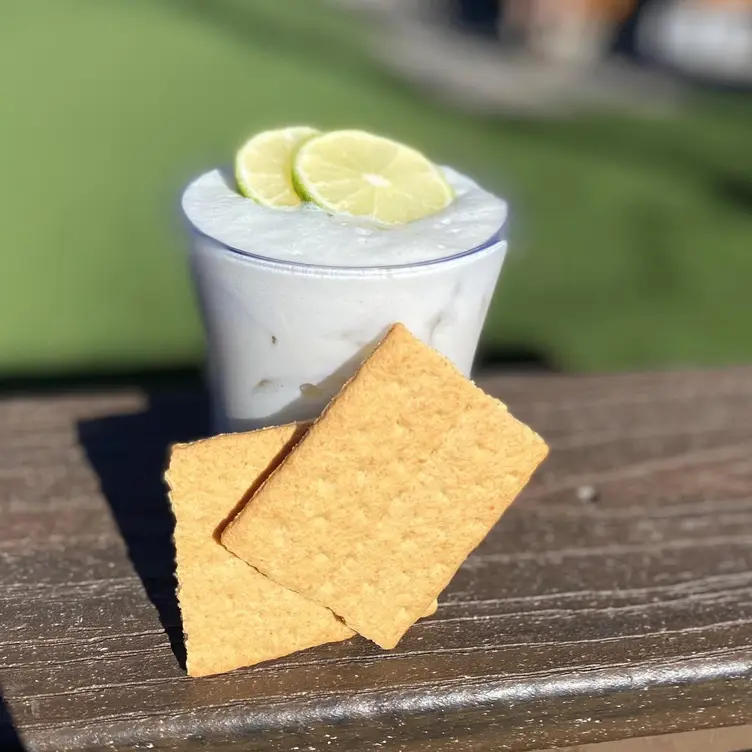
0;0;752;377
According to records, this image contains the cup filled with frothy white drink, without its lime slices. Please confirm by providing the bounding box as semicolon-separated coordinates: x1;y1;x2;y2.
182;156;507;432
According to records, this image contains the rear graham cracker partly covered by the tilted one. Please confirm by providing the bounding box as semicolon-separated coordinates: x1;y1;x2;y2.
165;424;354;676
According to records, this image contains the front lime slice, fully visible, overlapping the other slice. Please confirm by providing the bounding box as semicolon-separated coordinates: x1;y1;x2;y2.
292;130;454;225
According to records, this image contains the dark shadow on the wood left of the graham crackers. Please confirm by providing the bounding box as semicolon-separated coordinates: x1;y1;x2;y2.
78;392;208;668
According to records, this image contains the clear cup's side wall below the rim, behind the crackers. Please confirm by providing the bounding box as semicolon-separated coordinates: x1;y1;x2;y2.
185;188;507;433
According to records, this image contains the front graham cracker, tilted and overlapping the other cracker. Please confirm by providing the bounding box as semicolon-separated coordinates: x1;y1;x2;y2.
222;324;548;648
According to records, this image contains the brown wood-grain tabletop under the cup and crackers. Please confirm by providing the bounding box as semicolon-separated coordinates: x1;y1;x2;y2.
0;368;752;752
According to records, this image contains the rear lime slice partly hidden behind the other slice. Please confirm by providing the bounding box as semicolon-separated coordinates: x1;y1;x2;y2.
235;126;318;209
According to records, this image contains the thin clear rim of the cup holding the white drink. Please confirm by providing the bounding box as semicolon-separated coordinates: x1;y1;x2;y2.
180;178;509;274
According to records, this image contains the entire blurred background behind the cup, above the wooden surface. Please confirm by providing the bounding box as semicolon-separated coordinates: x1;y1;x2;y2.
0;0;752;381
